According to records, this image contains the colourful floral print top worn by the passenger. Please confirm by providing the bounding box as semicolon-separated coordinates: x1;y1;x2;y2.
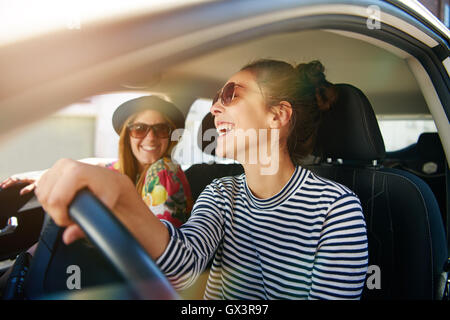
106;157;192;228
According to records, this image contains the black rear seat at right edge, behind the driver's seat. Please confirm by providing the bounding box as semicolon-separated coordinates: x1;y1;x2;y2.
383;132;447;225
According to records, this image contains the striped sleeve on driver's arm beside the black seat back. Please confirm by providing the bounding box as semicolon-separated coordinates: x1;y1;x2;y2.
309;194;368;299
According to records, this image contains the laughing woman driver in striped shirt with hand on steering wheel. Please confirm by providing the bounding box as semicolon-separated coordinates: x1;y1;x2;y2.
36;60;368;299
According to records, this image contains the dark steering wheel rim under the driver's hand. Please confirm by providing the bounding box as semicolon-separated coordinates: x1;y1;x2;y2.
69;189;178;299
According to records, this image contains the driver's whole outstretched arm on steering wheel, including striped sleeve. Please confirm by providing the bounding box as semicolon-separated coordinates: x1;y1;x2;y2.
36;159;224;288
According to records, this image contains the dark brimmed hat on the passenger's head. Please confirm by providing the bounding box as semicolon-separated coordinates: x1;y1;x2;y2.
112;96;184;134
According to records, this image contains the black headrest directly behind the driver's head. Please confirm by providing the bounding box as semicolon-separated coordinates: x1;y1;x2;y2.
313;84;386;161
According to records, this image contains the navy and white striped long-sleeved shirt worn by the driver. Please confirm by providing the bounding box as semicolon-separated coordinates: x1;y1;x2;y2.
156;166;368;300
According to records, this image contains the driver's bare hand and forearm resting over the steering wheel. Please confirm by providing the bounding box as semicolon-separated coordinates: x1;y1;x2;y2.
35;159;169;260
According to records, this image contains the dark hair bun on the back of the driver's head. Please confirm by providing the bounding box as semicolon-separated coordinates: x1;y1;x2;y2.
295;60;337;111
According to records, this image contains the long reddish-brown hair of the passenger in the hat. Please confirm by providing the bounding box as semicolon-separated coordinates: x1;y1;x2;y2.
118;113;177;194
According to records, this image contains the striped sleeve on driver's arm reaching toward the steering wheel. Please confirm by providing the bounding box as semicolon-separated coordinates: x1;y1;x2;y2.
156;184;224;290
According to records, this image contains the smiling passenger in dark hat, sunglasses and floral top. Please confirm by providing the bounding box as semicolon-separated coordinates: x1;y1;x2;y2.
107;96;192;227
